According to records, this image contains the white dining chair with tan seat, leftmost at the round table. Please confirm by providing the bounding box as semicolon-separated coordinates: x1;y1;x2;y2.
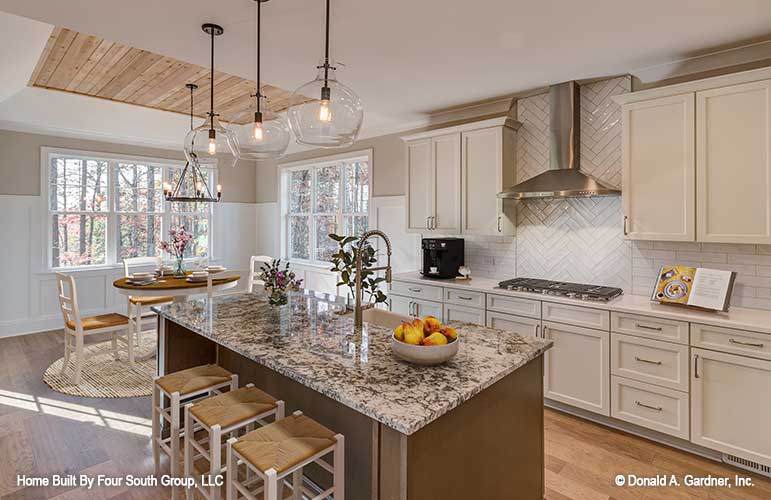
55;273;134;385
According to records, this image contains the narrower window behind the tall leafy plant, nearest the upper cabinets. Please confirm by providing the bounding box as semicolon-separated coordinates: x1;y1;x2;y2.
280;152;371;264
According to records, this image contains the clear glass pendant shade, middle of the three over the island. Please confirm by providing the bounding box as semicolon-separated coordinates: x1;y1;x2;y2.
233;96;291;160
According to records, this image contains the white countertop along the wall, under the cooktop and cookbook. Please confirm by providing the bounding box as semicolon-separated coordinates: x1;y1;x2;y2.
393;272;771;335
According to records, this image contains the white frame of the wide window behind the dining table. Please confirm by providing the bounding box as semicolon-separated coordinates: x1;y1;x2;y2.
40;146;219;272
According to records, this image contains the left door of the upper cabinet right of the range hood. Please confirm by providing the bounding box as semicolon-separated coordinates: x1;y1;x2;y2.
622;93;696;241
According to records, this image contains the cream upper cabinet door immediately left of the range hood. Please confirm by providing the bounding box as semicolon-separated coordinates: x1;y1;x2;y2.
460;127;513;235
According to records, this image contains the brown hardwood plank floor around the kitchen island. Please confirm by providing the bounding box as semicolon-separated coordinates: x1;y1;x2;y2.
0;332;771;500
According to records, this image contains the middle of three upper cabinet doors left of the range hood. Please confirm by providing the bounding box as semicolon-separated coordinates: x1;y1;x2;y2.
429;133;460;234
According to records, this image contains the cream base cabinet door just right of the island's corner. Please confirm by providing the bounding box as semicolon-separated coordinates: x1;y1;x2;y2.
543;321;610;416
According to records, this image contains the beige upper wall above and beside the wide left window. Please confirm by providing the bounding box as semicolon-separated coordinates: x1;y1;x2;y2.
0;130;257;203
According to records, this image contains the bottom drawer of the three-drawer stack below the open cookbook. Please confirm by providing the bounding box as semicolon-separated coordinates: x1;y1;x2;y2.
610;376;690;439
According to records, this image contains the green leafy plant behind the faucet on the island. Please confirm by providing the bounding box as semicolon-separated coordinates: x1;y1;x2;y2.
329;234;387;304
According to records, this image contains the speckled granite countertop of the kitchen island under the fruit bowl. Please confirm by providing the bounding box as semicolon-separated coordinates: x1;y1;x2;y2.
153;293;552;435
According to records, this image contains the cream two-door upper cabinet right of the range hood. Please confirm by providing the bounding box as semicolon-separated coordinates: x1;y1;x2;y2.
614;68;771;244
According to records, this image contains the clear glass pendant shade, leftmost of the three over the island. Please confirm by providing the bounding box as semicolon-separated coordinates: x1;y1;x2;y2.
184;114;241;167
